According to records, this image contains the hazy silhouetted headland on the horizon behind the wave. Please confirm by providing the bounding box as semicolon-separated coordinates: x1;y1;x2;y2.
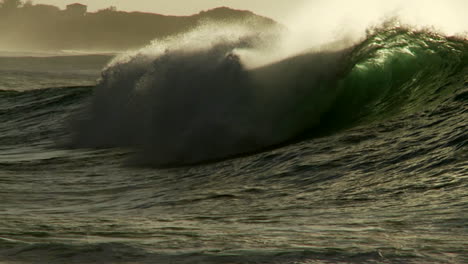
0;0;278;51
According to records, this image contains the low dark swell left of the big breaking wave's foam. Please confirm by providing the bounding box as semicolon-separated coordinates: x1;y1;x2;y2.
0;87;92;146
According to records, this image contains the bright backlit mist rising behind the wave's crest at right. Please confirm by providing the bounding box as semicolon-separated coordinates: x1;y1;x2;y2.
258;0;468;65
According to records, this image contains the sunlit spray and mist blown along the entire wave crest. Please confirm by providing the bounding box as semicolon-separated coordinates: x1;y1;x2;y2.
100;0;468;68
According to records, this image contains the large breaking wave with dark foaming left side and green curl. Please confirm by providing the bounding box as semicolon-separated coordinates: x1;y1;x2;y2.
63;24;468;166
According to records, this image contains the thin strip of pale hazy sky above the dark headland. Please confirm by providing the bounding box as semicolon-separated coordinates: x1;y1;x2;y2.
33;0;311;21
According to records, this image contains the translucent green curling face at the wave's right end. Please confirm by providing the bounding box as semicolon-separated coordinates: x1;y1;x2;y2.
323;28;468;128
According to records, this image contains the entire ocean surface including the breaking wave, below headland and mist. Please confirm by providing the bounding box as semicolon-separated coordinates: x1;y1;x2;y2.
0;27;468;264
